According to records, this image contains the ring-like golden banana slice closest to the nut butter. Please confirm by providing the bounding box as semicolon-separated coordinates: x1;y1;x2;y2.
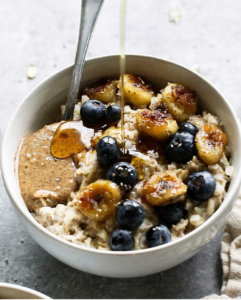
77;180;122;221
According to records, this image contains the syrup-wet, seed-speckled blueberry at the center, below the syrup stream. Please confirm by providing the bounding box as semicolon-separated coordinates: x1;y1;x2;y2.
106;162;138;191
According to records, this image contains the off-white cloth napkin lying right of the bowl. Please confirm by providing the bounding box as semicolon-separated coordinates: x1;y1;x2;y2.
204;194;241;299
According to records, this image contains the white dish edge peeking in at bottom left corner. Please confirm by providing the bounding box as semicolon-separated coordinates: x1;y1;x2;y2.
0;283;50;299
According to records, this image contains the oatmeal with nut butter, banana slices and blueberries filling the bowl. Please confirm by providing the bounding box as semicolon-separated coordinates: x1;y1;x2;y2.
17;74;234;251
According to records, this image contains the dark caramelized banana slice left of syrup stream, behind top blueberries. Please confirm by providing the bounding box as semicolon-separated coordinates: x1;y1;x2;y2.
82;79;118;103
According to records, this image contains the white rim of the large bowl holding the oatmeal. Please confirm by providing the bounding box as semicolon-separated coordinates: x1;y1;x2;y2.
1;53;241;256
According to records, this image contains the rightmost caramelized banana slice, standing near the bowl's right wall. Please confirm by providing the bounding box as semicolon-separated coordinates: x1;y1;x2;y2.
196;123;228;165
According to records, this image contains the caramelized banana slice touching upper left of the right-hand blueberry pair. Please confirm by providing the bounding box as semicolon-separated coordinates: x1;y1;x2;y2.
136;108;178;141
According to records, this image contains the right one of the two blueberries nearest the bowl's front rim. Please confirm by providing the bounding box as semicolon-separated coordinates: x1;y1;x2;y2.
146;225;172;248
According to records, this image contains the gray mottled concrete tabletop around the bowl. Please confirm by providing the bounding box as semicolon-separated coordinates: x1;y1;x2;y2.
0;0;241;298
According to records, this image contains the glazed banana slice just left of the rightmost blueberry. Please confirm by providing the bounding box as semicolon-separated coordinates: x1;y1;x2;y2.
143;172;187;206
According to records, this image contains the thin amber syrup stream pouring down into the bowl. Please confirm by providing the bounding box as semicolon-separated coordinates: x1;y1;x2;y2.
120;0;126;153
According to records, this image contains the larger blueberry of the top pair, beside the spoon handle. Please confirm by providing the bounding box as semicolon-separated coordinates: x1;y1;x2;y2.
80;100;106;124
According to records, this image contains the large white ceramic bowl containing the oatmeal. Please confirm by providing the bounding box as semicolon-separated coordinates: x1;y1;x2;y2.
1;55;241;277
